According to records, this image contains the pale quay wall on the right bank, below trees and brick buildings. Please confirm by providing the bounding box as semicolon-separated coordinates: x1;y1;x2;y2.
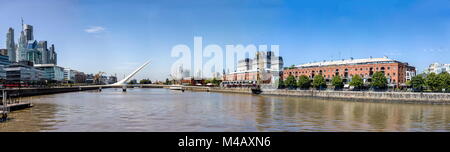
179;86;450;104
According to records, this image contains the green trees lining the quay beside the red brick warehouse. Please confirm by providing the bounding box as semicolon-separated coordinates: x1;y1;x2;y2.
278;72;450;92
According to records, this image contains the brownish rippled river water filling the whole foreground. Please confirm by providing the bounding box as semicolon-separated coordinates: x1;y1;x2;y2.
0;88;450;132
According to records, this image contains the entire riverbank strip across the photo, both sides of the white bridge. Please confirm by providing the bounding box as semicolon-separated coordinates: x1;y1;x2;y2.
4;85;450;104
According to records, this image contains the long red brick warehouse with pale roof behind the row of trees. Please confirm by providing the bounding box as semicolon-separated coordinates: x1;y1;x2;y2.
283;57;416;87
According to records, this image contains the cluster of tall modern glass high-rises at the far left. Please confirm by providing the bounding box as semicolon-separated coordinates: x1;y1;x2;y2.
0;20;64;83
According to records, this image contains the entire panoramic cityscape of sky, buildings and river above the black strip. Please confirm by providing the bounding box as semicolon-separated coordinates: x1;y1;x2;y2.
0;0;450;132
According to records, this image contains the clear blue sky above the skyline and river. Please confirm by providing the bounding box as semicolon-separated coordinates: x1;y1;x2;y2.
0;0;450;80
